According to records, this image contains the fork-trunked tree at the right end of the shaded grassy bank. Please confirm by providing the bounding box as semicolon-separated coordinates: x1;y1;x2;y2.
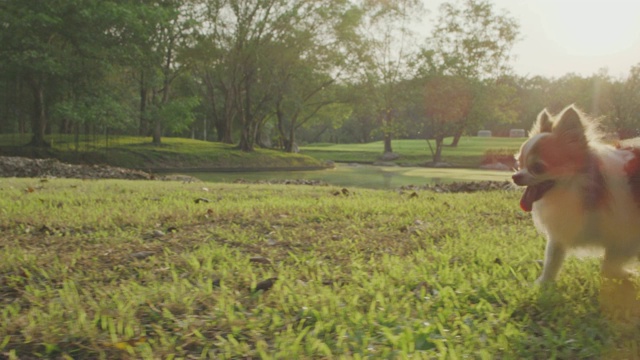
270;0;361;152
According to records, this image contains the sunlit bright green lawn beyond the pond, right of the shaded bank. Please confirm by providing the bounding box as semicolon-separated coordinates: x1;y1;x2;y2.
301;137;523;168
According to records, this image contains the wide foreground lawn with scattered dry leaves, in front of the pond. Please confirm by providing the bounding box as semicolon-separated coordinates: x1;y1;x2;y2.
0;179;640;359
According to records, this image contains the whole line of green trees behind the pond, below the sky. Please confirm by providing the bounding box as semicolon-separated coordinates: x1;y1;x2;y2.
0;0;640;152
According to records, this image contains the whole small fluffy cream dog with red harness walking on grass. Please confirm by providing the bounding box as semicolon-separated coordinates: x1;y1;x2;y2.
512;106;640;283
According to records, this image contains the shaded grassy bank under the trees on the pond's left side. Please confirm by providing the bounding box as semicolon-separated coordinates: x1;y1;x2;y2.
0;135;323;169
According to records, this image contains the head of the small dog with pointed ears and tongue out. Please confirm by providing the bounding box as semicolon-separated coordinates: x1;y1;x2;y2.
512;106;590;211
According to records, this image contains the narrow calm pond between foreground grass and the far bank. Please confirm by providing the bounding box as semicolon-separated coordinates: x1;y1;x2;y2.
180;164;511;189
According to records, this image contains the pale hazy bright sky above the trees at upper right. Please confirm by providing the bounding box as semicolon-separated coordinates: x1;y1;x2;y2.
423;0;640;77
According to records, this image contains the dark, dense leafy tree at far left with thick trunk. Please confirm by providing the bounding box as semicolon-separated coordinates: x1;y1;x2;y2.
0;0;162;147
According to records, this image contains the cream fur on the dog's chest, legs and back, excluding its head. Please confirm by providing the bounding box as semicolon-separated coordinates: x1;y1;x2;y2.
520;105;640;283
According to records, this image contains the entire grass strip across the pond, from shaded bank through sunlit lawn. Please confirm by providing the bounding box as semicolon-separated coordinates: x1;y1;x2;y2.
0;134;522;169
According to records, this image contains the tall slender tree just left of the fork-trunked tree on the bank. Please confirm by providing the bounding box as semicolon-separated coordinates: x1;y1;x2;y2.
208;0;292;151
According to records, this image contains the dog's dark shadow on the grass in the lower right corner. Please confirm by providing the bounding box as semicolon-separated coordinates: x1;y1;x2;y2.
512;279;640;359
